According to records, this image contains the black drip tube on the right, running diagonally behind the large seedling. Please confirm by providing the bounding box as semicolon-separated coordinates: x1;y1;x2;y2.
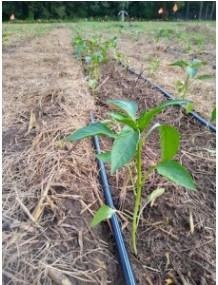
119;62;216;133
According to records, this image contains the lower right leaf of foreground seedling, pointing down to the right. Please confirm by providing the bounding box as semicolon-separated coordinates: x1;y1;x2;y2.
157;160;196;191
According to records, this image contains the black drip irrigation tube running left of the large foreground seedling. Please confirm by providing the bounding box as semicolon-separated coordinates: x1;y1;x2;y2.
90;113;136;285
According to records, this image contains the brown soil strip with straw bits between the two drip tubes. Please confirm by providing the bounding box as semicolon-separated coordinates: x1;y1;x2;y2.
94;63;216;285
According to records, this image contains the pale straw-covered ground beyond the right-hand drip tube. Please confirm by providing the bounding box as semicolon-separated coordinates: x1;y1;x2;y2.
116;25;216;119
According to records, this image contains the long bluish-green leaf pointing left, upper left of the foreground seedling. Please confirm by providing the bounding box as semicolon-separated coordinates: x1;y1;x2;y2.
66;122;116;142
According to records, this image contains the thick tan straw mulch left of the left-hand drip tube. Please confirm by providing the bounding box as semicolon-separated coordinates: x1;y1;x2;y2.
3;30;119;285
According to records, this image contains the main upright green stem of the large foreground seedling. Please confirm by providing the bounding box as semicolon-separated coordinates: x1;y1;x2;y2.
132;139;142;255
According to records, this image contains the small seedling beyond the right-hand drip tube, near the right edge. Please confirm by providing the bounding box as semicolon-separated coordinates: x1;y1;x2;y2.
170;59;212;113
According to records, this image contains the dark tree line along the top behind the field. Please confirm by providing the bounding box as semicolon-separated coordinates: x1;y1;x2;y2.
2;1;216;21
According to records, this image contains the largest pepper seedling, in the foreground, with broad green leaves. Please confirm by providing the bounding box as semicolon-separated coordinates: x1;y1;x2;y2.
67;100;196;254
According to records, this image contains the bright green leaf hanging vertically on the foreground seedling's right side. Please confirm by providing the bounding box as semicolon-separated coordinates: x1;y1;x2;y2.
160;125;180;160
